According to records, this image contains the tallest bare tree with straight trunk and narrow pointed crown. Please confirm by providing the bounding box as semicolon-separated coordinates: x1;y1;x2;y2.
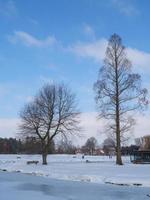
94;34;147;165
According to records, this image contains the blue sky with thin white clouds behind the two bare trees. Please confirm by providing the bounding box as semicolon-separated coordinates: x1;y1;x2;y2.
0;0;150;143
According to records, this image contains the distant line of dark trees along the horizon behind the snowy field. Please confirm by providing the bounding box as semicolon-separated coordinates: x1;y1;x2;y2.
0;135;150;156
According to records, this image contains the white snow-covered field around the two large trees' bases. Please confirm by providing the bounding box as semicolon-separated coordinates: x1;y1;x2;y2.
0;155;150;187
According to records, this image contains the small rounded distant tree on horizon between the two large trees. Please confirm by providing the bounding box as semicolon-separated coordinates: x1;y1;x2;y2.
84;137;97;155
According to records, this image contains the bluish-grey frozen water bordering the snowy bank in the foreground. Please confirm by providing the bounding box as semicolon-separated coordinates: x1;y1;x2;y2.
0;172;150;200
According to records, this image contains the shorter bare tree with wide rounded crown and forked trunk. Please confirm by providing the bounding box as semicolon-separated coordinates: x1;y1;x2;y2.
20;84;79;164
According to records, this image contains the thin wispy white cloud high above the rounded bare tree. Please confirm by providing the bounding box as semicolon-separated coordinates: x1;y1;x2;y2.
8;31;57;47
